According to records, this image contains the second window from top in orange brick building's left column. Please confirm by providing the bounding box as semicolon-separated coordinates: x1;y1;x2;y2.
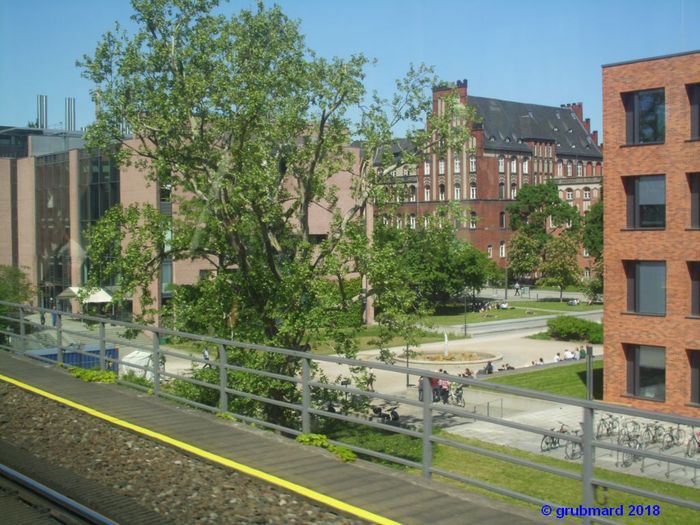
623;175;666;229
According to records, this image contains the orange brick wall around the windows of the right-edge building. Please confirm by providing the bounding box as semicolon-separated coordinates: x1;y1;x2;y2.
603;52;700;417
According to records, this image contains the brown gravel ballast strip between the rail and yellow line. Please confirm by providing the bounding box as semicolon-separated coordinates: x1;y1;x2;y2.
0;382;367;525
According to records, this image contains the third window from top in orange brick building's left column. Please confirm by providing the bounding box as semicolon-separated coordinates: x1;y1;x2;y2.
624;261;666;315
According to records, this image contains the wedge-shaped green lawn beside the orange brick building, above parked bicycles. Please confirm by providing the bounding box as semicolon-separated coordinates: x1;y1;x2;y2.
485;360;603;399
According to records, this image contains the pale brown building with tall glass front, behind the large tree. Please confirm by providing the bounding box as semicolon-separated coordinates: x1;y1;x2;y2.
0;126;360;320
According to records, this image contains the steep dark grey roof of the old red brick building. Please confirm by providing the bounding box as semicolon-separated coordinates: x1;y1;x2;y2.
467;95;602;159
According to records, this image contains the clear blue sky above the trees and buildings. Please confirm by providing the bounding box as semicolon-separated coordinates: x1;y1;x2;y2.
0;0;700;140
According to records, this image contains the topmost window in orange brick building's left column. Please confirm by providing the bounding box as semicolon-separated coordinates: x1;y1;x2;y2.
623;89;666;144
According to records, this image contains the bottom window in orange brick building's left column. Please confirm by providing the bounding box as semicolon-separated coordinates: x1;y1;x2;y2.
625;345;666;401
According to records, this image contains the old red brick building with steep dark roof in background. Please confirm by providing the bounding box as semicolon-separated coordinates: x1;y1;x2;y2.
397;80;603;272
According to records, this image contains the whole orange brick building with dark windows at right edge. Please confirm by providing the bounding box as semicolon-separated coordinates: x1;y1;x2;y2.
603;51;700;417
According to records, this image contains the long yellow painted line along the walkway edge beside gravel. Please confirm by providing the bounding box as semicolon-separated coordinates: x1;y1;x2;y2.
0;374;400;525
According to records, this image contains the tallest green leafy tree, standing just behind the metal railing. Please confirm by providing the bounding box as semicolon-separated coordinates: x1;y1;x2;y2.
79;0;474;423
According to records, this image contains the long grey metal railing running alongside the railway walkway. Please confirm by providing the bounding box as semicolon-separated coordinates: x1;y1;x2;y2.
0;302;700;524
